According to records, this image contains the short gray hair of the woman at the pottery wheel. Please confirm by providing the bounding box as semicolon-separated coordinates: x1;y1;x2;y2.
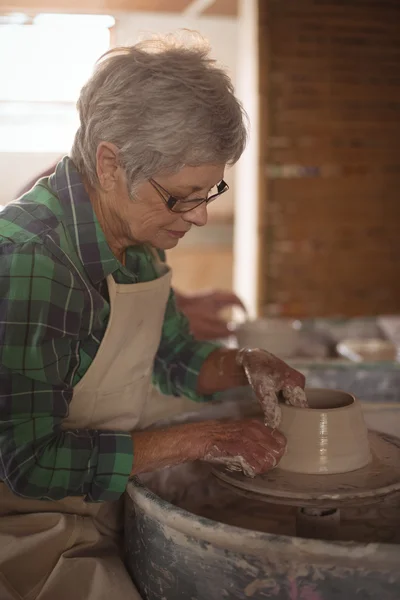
71;32;247;189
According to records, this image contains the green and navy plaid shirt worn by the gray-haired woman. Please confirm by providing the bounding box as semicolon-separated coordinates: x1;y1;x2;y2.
0;158;216;502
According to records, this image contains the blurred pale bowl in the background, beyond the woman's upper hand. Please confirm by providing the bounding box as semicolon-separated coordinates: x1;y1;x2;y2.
235;319;300;358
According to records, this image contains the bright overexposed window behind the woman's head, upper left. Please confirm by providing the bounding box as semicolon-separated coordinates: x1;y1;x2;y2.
0;14;115;153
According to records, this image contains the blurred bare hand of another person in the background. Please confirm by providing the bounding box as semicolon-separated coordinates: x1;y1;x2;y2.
175;290;245;340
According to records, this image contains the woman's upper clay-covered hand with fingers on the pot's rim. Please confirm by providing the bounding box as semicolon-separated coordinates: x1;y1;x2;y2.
236;348;308;429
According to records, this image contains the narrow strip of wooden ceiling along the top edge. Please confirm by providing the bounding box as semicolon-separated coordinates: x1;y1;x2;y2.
0;0;238;17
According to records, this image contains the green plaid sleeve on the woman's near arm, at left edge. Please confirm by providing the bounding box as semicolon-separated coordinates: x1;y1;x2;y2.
0;242;133;501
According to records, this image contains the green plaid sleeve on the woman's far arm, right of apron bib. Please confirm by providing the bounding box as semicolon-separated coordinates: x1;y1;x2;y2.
153;290;220;402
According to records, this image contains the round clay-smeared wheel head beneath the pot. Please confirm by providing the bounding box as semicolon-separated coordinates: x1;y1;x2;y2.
213;431;400;508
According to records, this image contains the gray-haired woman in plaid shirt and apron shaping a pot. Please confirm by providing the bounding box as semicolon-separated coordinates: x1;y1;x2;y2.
0;40;304;600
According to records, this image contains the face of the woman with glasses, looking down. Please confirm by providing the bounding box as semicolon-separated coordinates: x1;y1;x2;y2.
99;144;225;250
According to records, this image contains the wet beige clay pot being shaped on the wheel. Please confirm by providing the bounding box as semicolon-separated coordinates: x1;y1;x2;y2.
279;389;371;474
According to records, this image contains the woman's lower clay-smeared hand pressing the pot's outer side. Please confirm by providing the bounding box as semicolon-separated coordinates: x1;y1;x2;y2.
202;419;286;477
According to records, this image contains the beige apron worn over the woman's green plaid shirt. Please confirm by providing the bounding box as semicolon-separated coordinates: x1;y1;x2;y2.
0;252;172;600
